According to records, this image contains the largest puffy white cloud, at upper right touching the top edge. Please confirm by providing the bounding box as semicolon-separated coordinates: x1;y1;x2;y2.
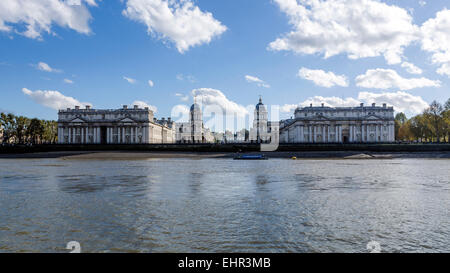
268;0;418;64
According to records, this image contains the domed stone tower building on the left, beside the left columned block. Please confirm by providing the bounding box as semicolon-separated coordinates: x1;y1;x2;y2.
175;103;214;143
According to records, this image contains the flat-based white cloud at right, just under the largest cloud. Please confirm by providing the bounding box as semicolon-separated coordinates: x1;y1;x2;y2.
356;68;441;90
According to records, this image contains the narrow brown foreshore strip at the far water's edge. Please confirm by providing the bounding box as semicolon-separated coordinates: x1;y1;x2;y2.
0;151;450;160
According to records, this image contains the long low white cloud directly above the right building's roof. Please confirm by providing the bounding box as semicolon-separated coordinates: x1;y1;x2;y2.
281;91;429;115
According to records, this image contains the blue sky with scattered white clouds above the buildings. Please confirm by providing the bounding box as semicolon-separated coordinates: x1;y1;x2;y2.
0;0;450;129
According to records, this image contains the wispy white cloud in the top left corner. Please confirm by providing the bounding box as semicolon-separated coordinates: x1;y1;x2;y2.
0;0;95;39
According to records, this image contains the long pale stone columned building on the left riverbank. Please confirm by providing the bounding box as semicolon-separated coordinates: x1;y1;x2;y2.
58;105;175;144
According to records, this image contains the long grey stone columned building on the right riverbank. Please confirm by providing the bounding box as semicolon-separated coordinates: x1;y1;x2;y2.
280;103;395;143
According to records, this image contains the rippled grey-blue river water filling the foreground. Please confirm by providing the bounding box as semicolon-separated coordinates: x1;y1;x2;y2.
0;159;450;253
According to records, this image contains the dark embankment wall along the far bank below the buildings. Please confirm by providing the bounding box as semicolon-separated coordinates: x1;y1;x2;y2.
0;143;450;158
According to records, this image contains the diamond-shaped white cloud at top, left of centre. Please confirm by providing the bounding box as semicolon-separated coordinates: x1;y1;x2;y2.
123;0;227;53
